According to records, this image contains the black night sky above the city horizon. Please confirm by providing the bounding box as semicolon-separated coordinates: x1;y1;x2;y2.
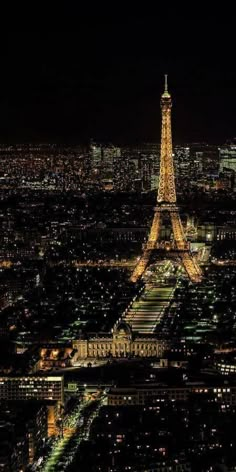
3;6;236;144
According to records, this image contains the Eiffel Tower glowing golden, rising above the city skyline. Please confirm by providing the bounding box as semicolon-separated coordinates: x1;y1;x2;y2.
131;75;202;282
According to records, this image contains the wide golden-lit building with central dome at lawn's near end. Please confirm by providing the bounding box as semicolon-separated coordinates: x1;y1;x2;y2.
72;320;168;361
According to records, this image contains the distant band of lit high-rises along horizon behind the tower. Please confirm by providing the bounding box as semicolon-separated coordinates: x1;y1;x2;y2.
0;140;236;192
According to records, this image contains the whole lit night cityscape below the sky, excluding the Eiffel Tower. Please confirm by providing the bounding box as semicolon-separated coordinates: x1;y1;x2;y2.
0;140;236;472
